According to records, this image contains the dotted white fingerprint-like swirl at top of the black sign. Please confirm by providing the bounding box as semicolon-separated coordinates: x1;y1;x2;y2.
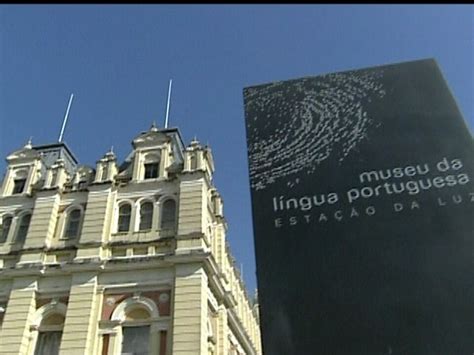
244;69;385;190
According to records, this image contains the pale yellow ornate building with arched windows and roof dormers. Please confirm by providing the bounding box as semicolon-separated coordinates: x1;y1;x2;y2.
0;125;261;355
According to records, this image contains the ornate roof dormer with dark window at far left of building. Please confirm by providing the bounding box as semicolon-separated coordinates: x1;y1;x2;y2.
0;140;42;197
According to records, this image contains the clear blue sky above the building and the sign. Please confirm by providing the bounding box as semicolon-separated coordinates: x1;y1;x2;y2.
0;4;474;294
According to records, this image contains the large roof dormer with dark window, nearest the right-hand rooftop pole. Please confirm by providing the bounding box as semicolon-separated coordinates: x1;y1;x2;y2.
132;124;173;182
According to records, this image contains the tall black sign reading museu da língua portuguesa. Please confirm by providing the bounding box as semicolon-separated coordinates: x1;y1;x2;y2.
244;59;474;355
